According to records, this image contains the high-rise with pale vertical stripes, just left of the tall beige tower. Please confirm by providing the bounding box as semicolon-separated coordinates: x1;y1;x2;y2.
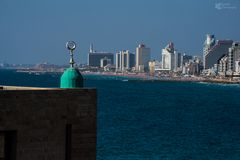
116;50;135;71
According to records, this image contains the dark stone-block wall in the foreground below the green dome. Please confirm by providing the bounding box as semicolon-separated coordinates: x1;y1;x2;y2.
0;87;97;160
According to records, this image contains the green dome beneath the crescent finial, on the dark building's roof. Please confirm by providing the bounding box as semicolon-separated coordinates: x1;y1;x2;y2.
60;67;83;88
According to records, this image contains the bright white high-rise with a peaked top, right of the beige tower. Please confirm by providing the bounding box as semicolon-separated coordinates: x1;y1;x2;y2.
162;42;174;71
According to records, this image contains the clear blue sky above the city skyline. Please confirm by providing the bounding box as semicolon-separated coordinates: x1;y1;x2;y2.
0;0;240;64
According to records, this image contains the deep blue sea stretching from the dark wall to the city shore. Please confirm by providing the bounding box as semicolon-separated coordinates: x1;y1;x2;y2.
0;70;240;160
